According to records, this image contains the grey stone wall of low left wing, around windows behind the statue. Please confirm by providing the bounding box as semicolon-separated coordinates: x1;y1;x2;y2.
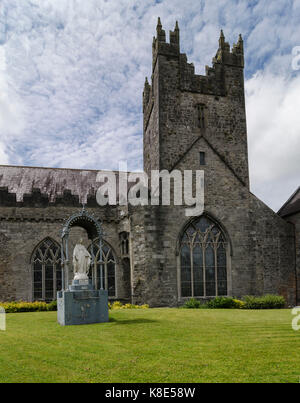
0;207;130;301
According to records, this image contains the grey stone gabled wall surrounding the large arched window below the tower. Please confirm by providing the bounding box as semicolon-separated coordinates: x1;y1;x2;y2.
131;138;295;306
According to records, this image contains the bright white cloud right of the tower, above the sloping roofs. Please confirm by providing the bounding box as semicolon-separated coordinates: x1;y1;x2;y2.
246;72;300;210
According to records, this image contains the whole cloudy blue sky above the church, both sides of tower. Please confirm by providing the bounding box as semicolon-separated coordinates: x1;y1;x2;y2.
0;0;300;210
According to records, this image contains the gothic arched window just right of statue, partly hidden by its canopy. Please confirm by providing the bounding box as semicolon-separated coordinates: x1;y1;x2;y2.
88;241;116;297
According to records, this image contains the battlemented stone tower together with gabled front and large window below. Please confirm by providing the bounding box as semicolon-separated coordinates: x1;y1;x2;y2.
135;19;296;304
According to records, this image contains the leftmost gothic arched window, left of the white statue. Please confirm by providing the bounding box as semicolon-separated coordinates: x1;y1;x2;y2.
31;238;61;301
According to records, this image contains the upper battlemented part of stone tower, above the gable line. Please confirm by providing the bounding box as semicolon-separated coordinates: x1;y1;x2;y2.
143;20;249;187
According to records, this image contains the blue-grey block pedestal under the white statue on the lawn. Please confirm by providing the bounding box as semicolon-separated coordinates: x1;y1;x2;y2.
57;280;108;326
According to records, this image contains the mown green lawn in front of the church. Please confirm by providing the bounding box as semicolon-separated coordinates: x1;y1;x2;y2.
0;308;300;383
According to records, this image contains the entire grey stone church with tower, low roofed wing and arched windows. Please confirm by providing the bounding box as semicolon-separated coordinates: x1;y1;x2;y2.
0;20;300;306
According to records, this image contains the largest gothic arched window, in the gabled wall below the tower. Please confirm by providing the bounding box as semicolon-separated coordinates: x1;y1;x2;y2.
180;215;227;297
